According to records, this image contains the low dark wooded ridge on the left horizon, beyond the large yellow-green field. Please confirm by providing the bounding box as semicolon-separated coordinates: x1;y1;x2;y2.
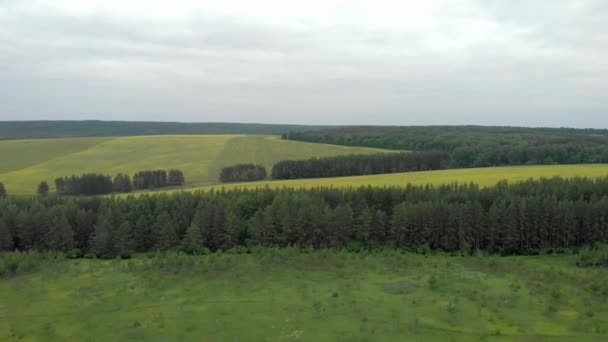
0;121;330;140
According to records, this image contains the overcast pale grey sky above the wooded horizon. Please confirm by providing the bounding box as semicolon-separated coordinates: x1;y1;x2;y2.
0;0;608;128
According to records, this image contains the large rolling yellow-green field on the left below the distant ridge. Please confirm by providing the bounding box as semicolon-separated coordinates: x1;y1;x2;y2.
0;135;384;194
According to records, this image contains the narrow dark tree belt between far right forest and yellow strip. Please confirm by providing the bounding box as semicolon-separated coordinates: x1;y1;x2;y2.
272;151;450;179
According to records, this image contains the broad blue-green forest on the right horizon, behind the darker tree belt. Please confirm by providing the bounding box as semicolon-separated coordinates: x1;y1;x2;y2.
283;126;608;168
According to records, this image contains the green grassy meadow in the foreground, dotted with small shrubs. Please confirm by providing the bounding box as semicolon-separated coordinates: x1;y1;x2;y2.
0;249;608;341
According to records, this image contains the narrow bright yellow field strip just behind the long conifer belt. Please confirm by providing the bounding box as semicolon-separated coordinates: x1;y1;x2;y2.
146;164;608;195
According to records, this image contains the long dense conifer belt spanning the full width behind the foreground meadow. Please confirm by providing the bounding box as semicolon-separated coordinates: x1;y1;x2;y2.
0;177;608;257
